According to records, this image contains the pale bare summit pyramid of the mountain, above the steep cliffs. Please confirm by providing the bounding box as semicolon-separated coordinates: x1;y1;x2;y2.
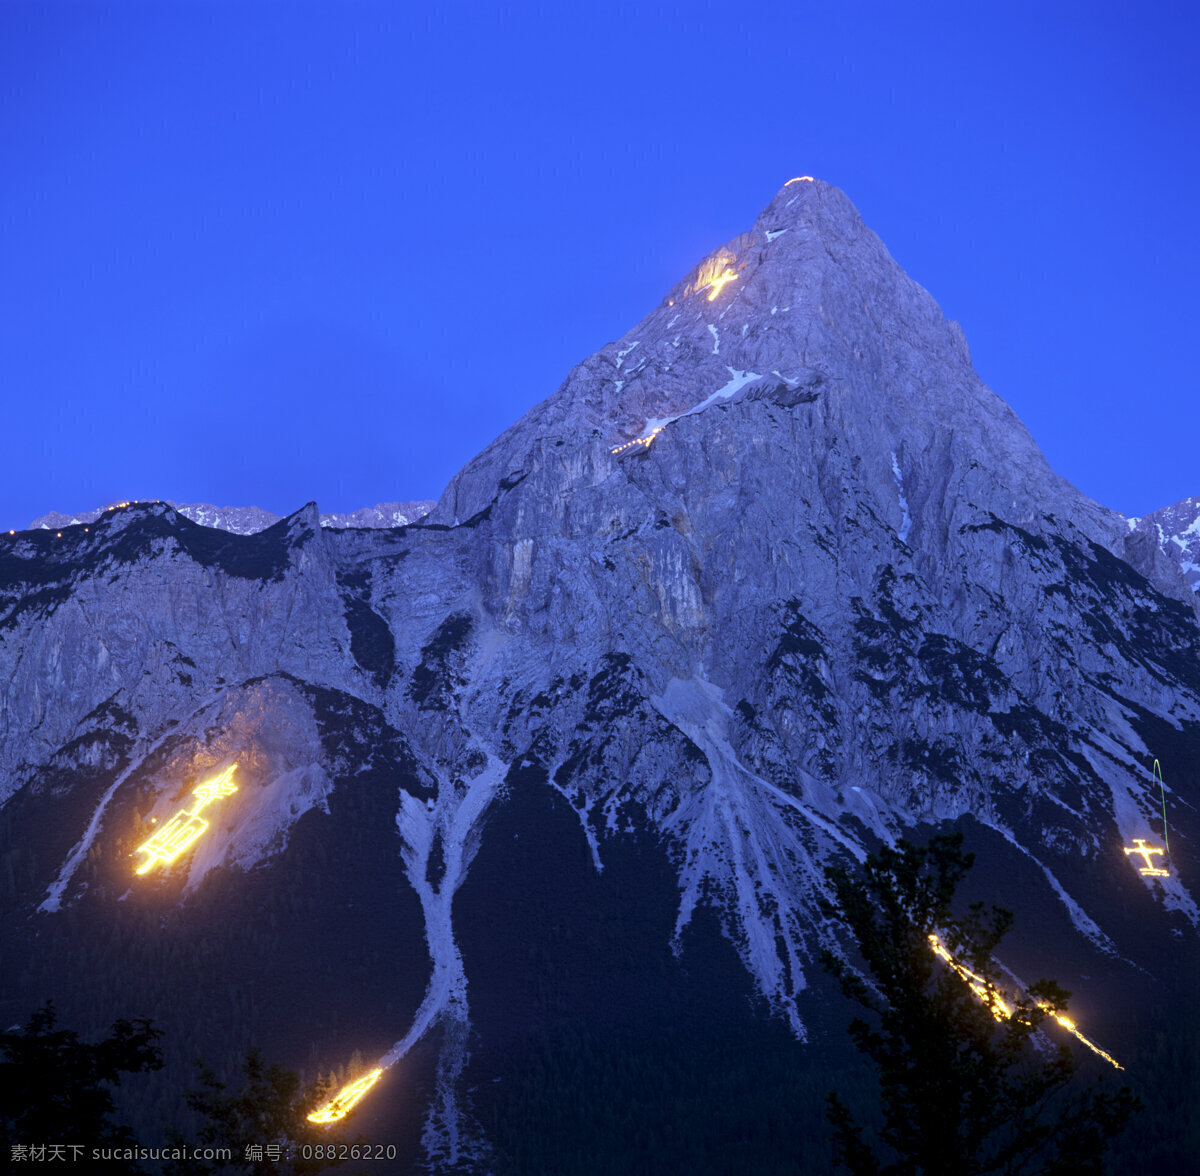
431;178;1126;564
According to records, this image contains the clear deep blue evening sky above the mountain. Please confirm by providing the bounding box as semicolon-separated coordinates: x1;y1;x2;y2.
0;0;1200;529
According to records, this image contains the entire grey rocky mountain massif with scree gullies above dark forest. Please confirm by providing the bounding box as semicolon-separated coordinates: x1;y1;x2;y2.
0;180;1200;1165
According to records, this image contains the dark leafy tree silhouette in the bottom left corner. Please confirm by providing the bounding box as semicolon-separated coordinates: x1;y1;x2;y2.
0;1001;162;1171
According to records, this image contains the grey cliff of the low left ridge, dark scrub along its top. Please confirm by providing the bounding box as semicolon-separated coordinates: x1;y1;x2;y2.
0;504;355;794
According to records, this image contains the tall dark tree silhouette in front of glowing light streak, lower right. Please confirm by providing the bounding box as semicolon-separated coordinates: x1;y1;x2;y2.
822;834;1141;1176
